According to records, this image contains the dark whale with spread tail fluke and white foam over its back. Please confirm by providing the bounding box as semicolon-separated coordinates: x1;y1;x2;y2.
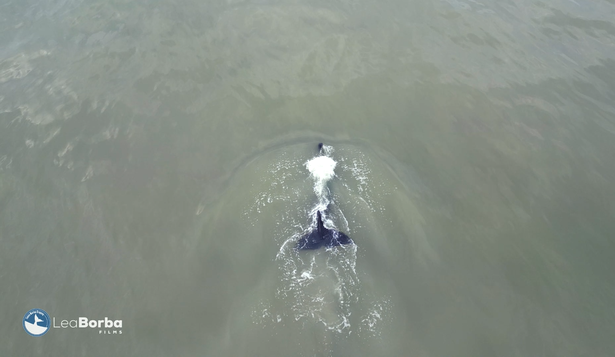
295;143;353;250
